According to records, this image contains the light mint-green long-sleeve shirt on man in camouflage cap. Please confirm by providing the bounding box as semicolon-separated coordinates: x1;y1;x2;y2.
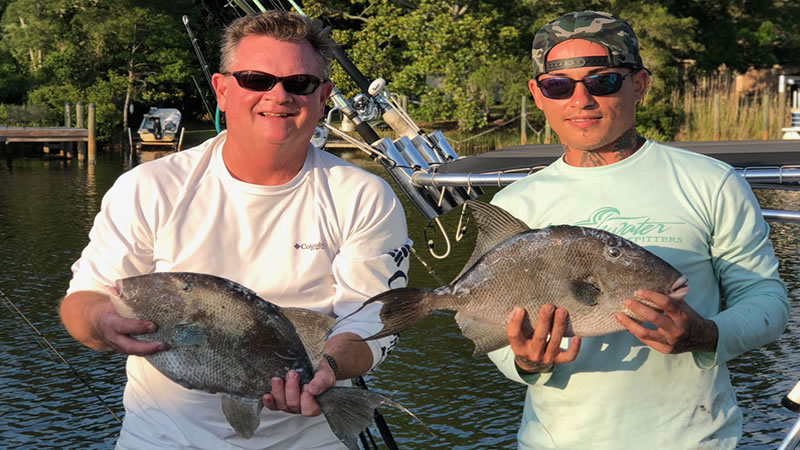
489;141;789;450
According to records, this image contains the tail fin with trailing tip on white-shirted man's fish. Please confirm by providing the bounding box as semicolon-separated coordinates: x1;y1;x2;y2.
317;387;435;450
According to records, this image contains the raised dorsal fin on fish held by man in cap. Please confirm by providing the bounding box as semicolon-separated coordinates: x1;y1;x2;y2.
455;200;530;280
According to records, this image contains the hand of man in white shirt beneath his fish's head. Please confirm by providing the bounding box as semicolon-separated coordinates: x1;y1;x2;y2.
61;291;166;355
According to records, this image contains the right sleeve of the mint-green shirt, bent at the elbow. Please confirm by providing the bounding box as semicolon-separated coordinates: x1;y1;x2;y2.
695;169;789;367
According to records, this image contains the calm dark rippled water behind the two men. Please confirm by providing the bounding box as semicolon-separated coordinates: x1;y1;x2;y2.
0;155;800;449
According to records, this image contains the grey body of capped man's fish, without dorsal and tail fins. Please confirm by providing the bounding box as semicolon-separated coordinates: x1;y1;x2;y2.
444;226;681;336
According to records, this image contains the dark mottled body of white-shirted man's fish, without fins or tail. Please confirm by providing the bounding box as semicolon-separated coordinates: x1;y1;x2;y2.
121;274;313;398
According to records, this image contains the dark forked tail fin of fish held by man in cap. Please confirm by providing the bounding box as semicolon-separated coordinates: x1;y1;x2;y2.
362;288;432;340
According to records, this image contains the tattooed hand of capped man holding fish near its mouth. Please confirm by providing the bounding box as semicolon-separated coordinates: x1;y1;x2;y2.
615;290;719;354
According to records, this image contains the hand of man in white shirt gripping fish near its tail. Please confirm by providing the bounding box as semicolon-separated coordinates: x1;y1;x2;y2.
261;359;336;416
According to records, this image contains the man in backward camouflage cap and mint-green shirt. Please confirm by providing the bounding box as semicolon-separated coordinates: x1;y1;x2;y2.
489;11;789;449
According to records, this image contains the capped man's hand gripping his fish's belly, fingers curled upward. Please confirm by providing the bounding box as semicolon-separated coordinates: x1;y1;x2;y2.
506;305;581;373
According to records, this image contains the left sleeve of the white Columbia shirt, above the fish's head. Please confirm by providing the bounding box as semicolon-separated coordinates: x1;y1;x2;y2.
67;172;157;294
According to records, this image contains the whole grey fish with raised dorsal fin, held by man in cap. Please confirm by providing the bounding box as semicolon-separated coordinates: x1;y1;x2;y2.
354;200;689;356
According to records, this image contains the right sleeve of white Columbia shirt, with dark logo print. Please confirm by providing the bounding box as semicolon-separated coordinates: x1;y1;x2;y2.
331;185;411;370
